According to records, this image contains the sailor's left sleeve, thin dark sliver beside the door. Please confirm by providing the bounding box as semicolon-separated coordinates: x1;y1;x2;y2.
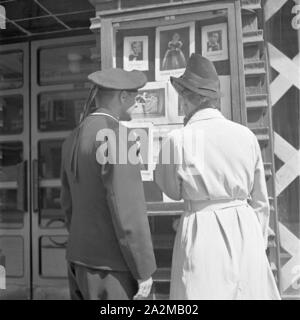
60;146;72;231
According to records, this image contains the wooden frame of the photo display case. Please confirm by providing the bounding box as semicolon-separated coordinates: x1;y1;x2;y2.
100;0;247;124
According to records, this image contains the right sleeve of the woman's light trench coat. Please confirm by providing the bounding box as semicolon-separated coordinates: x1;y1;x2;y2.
250;137;270;248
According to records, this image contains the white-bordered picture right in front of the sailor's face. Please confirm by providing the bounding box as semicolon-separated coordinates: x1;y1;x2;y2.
131;82;168;124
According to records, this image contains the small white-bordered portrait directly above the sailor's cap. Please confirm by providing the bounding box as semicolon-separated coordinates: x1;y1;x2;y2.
123;36;149;71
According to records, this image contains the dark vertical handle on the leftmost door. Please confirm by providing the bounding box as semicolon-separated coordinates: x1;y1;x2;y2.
17;160;28;212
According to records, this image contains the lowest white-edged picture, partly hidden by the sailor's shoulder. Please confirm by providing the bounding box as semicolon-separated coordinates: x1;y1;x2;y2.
122;121;154;181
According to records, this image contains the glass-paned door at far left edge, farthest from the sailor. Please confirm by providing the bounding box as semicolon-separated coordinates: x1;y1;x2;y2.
0;44;30;299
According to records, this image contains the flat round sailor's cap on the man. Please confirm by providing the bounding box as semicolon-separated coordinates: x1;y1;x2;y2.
88;68;147;90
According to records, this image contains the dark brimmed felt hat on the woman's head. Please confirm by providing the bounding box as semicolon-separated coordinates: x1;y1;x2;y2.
170;53;221;99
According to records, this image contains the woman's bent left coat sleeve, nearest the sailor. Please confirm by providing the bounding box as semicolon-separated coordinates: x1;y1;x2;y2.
154;131;182;200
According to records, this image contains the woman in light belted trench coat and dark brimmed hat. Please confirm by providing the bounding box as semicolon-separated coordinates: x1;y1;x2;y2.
155;54;280;300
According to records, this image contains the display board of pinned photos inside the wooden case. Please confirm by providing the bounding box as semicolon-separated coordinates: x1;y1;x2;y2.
113;9;232;180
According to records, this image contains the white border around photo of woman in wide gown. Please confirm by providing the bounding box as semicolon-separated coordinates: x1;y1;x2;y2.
155;22;195;81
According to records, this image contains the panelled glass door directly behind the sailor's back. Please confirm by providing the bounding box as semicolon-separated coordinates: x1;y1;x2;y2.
31;36;100;299
